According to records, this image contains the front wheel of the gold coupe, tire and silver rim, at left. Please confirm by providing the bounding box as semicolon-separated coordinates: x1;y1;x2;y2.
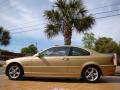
7;64;24;80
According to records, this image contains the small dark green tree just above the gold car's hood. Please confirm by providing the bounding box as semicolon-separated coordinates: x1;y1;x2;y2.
21;44;38;56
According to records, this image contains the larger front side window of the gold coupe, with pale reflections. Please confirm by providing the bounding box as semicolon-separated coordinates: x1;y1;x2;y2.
41;47;69;56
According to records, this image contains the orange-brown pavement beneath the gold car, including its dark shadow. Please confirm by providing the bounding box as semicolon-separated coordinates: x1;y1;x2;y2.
0;68;120;90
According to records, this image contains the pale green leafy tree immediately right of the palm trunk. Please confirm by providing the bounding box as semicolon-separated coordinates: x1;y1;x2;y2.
82;33;96;49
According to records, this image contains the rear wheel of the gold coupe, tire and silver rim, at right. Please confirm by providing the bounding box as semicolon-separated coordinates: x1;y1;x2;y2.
82;66;101;83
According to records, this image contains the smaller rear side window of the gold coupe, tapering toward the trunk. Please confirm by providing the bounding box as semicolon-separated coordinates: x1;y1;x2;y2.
70;47;90;56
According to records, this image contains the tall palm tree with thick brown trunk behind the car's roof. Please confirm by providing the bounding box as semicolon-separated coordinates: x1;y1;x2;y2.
44;0;95;45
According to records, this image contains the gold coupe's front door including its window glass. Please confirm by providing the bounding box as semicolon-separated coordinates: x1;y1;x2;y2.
32;47;69;77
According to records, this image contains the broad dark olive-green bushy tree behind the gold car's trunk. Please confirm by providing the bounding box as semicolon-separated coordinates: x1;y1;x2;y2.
95;37;119;54
